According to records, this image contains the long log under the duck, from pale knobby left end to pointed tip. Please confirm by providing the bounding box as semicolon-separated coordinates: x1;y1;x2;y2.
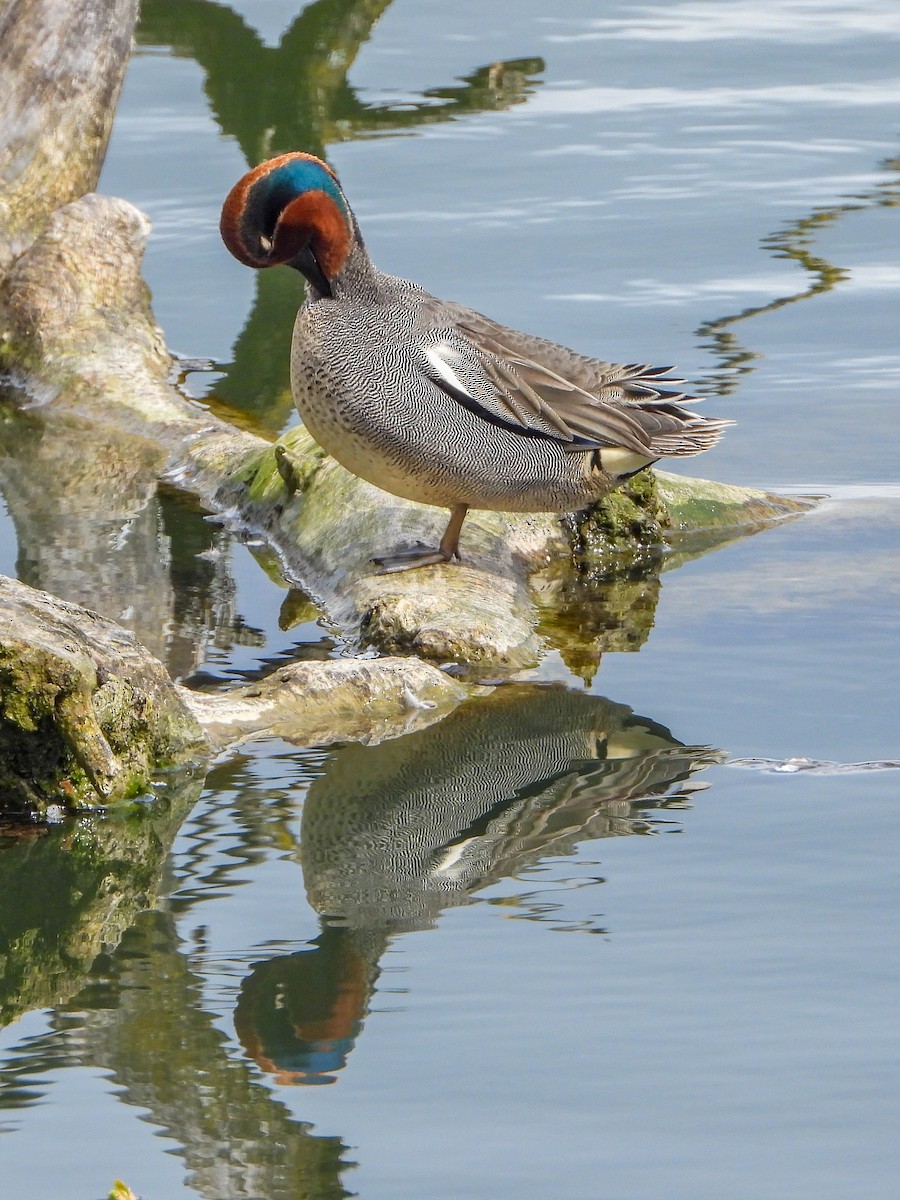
0;189;806;673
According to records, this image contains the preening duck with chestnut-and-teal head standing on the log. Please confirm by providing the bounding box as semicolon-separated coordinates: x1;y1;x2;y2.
220;151;732;574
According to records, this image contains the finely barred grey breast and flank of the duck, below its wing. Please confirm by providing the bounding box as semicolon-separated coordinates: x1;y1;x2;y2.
290;300;604;512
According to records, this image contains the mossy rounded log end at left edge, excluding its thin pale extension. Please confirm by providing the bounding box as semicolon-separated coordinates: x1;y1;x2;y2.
0;577;205;812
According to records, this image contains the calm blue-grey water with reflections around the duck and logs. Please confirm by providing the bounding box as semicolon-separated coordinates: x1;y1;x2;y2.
0;0;900;1200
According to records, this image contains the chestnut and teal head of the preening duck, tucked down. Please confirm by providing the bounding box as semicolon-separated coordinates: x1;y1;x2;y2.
218;151;355;296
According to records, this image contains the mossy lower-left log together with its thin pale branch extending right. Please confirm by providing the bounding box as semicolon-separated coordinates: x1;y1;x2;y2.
0;576;467;815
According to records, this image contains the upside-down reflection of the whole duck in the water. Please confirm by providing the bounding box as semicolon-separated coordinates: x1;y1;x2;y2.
235;685;721;1084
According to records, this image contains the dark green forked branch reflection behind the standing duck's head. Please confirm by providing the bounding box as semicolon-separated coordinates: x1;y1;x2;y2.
138;0;544;432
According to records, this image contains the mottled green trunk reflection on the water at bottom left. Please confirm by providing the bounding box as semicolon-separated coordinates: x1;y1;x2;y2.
0;912;353;1200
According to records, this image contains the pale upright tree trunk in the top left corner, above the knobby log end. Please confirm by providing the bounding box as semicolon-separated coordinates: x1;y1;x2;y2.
0;0;138;276
